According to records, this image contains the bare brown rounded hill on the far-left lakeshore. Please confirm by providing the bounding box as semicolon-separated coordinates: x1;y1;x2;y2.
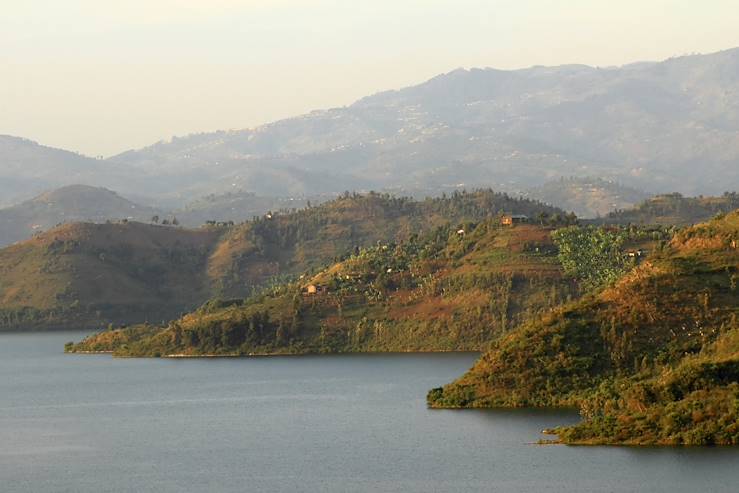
0;222;221;329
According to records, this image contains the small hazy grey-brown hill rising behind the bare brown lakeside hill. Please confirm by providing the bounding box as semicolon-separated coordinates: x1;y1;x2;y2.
0;185;159;246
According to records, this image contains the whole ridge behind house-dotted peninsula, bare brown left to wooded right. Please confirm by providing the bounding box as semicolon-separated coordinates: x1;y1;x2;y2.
0;191;563;329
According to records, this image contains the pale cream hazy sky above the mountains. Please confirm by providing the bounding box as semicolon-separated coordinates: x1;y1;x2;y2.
0;0;739;156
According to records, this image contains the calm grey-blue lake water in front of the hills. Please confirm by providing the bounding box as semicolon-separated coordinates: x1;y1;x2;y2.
0;333;739;493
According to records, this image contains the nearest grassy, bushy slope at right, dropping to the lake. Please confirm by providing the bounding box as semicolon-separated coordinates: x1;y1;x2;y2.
429;211;739;443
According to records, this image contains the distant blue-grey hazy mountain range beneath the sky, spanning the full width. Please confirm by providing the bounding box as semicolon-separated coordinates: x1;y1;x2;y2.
0;49;739;207
